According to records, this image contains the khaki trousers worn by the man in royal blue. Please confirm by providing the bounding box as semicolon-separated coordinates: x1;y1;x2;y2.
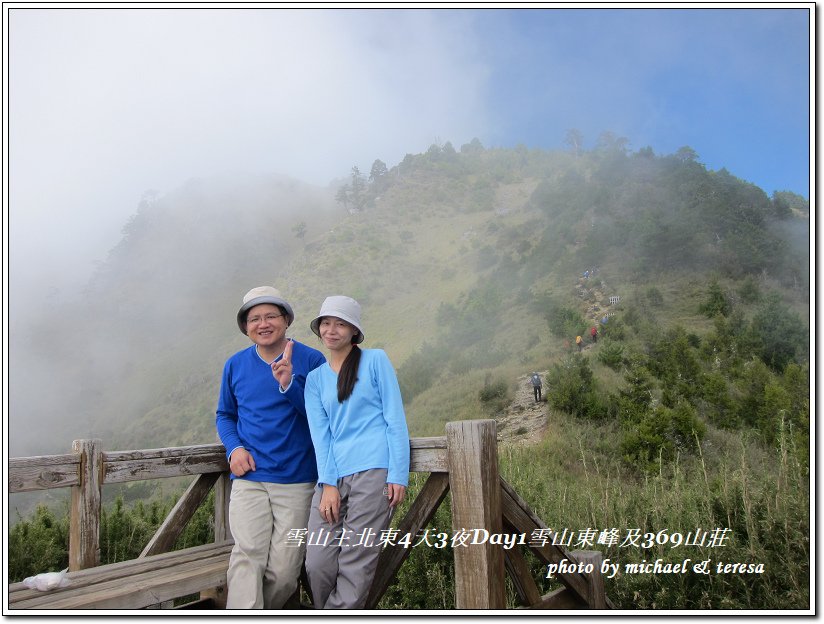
226;479;315;609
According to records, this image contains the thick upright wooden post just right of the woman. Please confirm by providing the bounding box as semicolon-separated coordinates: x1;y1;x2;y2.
446;420;506;609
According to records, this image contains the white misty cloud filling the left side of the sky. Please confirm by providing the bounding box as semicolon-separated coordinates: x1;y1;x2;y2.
10;9;488;302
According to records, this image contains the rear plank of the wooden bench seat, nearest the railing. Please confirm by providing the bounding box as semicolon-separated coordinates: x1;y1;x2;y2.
9;542;233;603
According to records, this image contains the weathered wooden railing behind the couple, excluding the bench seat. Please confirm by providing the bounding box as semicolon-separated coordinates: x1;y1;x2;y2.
8;420;612;609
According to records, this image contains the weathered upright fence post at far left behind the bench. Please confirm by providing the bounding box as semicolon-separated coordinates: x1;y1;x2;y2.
69;440;103;571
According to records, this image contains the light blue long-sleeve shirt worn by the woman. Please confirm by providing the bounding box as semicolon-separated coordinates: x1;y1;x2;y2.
305;349;409;485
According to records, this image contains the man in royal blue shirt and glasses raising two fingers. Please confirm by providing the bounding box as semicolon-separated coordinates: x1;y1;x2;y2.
216;286;326;609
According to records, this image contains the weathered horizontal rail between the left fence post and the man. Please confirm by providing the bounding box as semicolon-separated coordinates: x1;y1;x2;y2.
103;444;229;483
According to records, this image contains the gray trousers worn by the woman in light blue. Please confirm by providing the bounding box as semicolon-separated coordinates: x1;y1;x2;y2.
306;468;394;609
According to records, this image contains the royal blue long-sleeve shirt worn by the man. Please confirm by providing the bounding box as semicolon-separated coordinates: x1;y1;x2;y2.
215;341;326;483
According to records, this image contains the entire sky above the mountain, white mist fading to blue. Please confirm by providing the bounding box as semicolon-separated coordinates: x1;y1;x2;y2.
4;3;813;298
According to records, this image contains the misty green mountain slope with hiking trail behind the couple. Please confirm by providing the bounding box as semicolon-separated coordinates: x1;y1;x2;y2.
12;142;810;609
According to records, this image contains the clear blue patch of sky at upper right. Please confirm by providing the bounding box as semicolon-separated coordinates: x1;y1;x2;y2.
478;8;810;198
